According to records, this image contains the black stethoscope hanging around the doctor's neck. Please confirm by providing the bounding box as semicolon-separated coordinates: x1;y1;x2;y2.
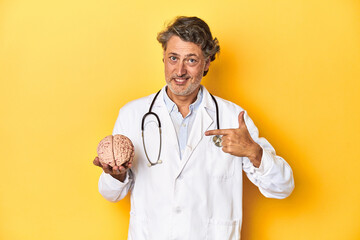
141;90;222;167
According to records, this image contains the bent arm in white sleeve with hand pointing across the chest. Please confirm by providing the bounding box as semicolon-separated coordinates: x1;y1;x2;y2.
206;112;294;198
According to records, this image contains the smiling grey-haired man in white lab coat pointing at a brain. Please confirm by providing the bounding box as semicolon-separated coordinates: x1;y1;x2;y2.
94;17;294;240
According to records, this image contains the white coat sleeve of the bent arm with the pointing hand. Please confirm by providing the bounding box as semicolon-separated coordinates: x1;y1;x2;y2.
243;111;294;199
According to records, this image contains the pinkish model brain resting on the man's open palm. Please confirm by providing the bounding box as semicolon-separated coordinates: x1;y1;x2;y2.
97;134;134;167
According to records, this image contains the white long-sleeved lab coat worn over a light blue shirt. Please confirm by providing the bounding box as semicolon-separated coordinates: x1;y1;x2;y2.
99;87;294;240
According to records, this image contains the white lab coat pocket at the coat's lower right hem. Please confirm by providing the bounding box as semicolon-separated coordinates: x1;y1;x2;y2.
206;219;240;240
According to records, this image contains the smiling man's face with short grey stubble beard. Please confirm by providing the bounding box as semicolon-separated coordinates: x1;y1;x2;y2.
164;35;210;96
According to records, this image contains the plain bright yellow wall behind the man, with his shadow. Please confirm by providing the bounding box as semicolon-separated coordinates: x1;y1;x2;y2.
0;0;360;240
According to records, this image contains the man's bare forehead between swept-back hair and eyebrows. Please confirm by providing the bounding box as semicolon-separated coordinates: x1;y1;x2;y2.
165;35;202;57
